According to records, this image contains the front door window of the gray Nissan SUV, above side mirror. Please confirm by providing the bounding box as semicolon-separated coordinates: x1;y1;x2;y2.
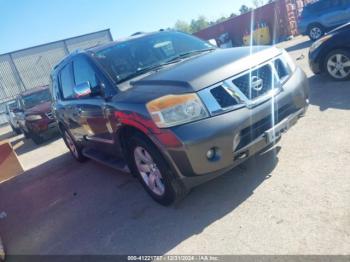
73;57;99;88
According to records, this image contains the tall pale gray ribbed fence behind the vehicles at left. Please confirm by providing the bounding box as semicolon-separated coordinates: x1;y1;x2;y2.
0;29;113;125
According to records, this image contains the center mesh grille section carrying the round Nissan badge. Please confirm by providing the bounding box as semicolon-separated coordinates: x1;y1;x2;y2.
232;64;274;100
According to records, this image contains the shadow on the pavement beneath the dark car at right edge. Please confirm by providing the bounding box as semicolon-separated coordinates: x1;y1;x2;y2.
309;75;350;111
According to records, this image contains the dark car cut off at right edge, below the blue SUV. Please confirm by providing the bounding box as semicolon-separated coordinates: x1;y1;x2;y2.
309;23;350;80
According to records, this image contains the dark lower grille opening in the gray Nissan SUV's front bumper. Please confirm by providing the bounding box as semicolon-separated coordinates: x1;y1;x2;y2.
236;104;297;150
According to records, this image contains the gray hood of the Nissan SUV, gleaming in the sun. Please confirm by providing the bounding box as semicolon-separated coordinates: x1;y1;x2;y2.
132;46;281;92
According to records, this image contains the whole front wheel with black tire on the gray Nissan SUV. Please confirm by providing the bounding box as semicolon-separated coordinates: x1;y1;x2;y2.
128;135;187;206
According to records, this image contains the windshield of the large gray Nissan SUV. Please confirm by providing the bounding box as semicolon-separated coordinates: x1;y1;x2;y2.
95;32;215;83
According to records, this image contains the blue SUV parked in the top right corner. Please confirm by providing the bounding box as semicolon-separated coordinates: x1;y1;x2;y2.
298;0;350;41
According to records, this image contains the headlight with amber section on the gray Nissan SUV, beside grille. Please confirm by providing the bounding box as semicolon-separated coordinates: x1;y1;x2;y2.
146;94;209;128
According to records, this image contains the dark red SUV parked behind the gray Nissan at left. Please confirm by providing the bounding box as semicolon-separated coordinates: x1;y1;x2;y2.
16;86;58;144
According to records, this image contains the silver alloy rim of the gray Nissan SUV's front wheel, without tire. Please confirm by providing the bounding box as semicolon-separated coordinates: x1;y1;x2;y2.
134;146;165;196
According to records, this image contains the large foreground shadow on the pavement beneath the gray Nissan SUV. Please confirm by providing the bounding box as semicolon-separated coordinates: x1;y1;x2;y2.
0;147;280;254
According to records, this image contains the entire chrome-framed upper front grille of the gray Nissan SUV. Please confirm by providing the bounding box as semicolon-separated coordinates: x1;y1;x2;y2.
198;55;291;115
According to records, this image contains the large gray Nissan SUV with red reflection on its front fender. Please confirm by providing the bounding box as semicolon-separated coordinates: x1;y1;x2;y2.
51;31;309;205
